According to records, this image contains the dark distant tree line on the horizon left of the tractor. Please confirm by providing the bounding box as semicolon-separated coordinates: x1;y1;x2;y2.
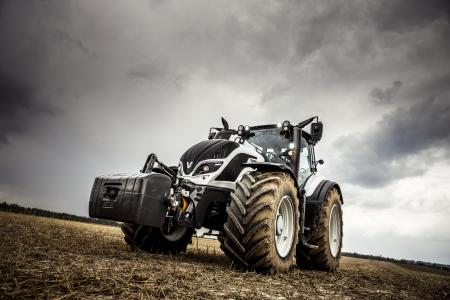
0;202;120;226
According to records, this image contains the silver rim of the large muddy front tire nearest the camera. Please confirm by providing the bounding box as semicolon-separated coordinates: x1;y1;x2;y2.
275;196;295;257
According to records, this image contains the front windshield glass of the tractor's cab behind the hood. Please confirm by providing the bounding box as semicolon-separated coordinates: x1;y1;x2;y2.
245;128;293;164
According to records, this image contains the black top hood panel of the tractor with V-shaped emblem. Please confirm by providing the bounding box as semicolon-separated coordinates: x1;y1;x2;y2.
180;139;239;174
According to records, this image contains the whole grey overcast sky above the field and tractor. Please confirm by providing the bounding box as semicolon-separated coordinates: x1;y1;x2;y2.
0;0;450;264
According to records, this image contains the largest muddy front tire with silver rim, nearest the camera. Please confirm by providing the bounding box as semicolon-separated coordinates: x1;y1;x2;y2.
219;172;299;273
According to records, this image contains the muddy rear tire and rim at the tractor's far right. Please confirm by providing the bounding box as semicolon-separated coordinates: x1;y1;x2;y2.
297;188;343;272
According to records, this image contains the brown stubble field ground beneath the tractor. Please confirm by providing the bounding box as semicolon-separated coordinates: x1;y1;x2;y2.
0;212;450;299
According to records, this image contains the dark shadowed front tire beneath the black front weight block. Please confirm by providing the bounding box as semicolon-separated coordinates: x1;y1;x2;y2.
121;223;194;254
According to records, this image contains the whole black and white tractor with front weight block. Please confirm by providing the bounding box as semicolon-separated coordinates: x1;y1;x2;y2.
89;117;343;273
